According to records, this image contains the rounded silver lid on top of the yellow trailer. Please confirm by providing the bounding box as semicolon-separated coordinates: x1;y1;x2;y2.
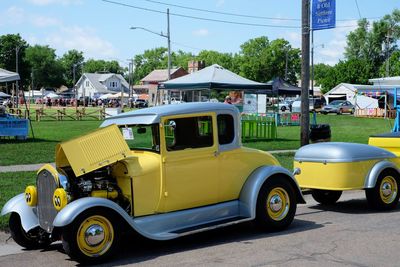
294;142;396;163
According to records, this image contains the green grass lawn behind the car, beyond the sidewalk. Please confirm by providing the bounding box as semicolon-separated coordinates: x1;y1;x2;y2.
0;115;393;166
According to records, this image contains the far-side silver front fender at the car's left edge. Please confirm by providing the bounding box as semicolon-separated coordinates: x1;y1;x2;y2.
1;193;39;232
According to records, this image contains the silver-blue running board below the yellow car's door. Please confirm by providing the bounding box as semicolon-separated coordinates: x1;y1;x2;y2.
132;200;253;240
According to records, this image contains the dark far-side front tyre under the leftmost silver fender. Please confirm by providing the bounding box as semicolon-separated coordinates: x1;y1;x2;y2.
9;212;51;249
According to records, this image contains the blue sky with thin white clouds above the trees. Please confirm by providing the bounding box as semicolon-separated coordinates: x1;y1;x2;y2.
0;0;400;66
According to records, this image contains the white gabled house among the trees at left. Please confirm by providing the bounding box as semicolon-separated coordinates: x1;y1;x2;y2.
76;73;129;98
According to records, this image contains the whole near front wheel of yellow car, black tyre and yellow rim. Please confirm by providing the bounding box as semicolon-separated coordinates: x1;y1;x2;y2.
62;209;121;264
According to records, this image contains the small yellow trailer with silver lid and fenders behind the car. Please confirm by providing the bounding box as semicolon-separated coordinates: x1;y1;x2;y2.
294;138;400;210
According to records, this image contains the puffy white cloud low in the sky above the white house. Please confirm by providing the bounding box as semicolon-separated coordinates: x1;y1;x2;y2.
45;26;117;58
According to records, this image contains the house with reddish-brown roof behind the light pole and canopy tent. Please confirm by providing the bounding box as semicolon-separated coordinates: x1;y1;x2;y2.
133;67;188;105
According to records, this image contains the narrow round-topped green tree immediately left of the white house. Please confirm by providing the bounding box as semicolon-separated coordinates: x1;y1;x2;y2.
60;49;85;87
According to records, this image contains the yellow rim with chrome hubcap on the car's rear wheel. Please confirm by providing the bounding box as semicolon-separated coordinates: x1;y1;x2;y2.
266;187;290;221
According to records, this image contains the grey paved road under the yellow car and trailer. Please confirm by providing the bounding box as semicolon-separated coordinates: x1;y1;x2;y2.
0;191;400;266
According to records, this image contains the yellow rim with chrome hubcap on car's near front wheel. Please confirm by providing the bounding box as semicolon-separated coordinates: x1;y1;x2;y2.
76;215;114;257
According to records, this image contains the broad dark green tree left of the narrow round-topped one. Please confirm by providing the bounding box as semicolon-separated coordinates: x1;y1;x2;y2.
25;45;63;89
